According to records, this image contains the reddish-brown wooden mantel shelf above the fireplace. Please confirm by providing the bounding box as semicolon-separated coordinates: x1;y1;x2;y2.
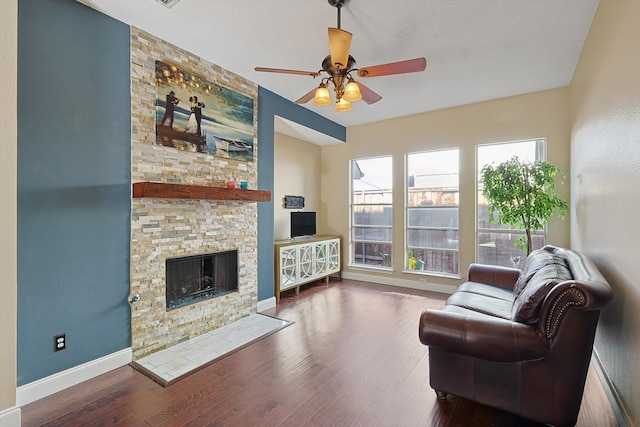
133;182;271;202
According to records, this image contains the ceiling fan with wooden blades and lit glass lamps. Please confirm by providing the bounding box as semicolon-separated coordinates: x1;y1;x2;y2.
255;0;427;111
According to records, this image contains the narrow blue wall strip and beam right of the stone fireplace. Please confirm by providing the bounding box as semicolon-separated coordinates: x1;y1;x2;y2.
258;87;347;301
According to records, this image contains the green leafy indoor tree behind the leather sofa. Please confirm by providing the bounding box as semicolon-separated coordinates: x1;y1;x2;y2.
481;156;569;255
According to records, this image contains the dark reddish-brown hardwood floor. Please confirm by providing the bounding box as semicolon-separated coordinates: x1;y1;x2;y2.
22;280;617;427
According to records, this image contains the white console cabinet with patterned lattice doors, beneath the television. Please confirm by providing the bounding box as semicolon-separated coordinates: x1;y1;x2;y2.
275;236;340;302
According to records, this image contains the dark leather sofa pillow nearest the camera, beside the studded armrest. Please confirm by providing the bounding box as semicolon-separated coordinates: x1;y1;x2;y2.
511;256;573;324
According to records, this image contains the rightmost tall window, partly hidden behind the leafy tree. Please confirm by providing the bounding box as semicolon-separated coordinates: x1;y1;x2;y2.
476;139;546;267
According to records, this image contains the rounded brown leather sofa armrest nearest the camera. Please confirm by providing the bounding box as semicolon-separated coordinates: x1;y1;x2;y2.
419;310;549;362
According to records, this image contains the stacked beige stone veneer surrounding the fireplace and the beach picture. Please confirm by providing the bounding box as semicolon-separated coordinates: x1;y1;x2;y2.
130;27;258;360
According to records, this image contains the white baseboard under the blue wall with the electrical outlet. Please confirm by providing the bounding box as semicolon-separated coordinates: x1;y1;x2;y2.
16;348;133;406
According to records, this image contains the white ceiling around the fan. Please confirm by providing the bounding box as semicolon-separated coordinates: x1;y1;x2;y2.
77;0;598;132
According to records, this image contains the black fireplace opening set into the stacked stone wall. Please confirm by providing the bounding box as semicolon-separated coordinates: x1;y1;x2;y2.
166;250;238;310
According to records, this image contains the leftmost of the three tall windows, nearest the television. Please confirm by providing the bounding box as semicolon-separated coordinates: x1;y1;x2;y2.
350;156;393;269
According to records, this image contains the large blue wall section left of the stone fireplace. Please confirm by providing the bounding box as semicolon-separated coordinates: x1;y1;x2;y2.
17;0;131;385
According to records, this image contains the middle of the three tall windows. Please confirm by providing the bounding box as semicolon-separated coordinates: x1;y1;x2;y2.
405;149;460;275
